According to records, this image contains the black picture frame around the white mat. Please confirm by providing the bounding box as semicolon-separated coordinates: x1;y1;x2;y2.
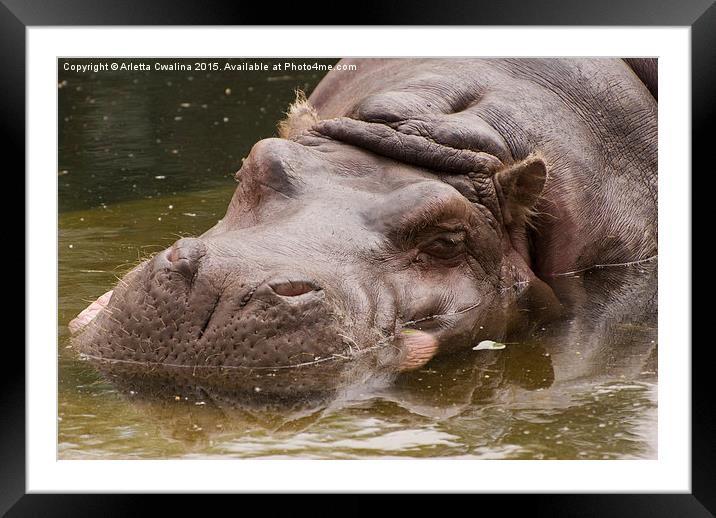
7;0;716;517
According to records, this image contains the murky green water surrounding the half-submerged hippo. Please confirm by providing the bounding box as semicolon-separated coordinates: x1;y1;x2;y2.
58;60;657;459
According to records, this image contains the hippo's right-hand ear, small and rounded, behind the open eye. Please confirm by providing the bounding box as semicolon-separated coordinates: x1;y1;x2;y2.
495;156;547;226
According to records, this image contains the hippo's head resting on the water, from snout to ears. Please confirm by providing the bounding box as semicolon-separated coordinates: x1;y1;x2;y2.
75;110;555;397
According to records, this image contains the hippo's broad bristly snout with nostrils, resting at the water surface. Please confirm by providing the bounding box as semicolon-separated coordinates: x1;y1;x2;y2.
70;238;392;402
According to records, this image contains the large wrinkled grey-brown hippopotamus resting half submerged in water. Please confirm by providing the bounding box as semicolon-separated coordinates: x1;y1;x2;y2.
70;58;657;406
